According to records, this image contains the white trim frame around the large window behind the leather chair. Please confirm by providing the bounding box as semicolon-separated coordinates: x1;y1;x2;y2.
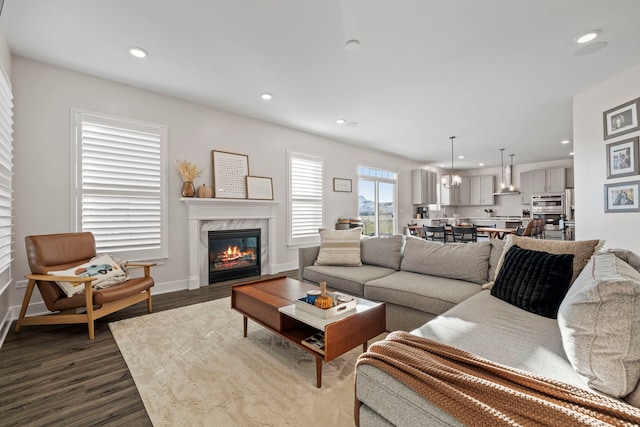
70;108;169;261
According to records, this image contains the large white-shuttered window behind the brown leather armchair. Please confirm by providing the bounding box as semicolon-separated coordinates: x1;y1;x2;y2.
72;110;168;260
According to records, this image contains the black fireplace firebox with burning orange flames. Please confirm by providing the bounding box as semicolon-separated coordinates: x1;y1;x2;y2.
208;228;261;283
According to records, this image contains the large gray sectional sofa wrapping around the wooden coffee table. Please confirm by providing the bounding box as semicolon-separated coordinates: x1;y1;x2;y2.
300;236;640;426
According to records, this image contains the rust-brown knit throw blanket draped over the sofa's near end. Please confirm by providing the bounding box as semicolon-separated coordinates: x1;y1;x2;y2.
355;331;640;427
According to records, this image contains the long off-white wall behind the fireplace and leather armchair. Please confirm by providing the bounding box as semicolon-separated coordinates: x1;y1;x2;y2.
8;57;416;310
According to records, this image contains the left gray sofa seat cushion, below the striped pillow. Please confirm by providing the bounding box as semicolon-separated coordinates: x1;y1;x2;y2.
302;265;396;296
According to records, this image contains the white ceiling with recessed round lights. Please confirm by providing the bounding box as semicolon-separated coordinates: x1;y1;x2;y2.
0;0;640;169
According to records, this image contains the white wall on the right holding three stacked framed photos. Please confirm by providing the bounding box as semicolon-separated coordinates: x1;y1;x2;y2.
573;66;640;253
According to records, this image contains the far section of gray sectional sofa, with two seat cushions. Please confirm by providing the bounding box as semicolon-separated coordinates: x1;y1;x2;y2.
298;235;504;331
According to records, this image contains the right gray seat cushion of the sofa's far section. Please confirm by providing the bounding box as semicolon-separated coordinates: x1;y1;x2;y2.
364;271;482;314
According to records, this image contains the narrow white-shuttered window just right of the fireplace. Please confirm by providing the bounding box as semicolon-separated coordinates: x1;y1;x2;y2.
287;151;324;245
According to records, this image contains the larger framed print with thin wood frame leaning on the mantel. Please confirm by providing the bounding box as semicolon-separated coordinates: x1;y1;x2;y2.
211;150;249;199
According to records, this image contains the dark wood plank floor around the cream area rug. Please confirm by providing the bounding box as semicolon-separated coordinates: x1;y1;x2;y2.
0;270;298;426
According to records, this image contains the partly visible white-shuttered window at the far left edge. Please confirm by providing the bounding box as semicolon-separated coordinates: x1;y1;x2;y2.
0;66;13;284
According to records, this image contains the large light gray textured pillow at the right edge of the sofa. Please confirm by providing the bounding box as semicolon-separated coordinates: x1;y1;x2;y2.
558;253;640;397
